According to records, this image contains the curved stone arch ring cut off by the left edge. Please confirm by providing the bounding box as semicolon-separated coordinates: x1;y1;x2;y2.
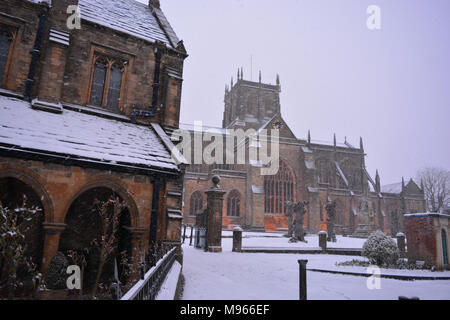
0;164;54;223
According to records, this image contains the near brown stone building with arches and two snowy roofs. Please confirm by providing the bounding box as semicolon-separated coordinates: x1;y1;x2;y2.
0;0;187;290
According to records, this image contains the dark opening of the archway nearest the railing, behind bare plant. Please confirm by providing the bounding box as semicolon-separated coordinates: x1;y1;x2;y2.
58;177;135;288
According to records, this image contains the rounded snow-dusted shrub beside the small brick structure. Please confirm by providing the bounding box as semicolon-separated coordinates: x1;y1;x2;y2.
362;230;399;266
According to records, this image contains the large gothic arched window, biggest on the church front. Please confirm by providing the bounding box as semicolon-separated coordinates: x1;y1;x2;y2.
264;159;295;215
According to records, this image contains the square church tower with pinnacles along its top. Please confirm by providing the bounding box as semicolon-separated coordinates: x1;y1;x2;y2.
222;68;281;129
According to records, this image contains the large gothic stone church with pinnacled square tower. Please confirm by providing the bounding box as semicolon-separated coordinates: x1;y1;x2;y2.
184;70;425;235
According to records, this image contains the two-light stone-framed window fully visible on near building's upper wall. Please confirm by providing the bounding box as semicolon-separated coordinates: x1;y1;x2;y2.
89;56;127;111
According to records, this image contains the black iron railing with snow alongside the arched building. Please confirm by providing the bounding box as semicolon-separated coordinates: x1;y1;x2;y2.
121;247;177;300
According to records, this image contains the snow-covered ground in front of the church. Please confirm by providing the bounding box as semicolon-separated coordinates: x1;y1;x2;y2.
183;231;450;300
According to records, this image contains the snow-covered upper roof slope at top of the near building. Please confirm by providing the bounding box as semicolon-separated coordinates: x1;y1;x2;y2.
78;0;179;48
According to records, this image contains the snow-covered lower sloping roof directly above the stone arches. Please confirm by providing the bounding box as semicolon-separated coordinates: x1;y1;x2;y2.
0;96;178;170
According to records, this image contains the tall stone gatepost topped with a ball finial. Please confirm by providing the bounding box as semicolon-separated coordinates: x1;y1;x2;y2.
205;176;226;252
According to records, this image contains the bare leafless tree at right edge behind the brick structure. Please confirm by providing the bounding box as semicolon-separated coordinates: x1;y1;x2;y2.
417;167;450;212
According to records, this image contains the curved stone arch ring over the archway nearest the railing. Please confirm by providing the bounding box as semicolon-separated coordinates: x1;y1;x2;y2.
64;175;139;227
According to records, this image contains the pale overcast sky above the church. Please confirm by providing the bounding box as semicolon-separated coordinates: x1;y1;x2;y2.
142;0;450;185
